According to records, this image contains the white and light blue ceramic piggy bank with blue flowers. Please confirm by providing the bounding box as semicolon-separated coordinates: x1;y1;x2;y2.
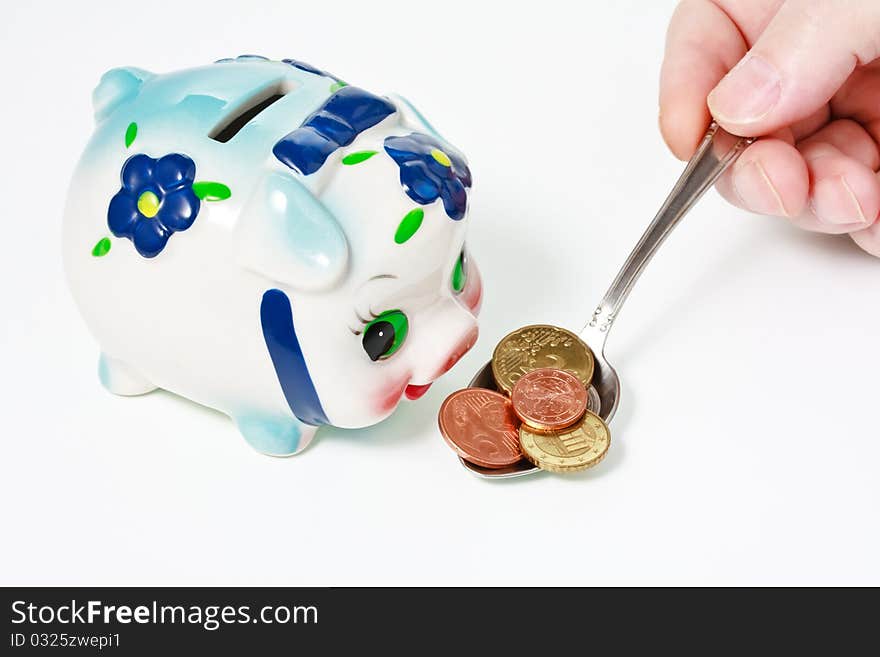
63;56;482;455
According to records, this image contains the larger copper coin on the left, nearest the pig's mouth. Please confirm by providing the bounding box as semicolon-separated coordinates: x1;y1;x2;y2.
439;388;522;468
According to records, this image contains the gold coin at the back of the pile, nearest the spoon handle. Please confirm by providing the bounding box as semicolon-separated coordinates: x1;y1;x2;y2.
492;324;593;395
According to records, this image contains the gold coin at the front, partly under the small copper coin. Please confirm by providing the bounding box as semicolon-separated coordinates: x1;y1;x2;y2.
519;411;611;472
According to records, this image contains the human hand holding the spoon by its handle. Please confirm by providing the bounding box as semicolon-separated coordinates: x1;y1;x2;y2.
660;0;880;256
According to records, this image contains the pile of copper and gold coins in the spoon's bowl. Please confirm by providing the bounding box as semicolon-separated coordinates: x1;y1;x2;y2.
439;324;611;472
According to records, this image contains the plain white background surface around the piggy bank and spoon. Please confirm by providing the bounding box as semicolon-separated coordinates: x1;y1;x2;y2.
0;0;880;585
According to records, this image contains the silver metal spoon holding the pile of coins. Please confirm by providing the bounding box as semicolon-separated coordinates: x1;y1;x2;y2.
459;121;754;479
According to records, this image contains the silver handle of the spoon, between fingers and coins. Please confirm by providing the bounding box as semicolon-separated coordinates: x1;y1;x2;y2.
581;121;754;346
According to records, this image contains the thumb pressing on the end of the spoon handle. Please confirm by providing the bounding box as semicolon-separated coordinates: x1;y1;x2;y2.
708;0;880;137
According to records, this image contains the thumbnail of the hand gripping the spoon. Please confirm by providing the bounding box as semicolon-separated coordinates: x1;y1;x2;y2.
708;55;782;124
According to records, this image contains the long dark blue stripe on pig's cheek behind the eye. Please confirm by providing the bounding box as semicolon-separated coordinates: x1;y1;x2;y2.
260;289;329;425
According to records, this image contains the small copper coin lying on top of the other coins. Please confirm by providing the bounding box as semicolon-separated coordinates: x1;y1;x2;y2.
511;367;587;431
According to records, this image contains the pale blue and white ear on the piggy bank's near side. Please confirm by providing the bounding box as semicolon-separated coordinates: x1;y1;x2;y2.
238;172;348;290
